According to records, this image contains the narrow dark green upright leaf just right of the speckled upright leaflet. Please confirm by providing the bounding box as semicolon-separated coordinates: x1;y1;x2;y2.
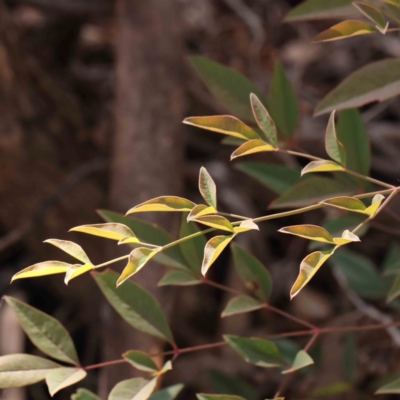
268;62;299;139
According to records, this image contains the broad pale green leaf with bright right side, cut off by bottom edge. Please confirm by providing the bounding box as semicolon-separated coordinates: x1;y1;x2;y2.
108;378;157;400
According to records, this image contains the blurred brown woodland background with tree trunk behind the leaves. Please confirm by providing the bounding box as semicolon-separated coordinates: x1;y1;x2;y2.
0;0;400;400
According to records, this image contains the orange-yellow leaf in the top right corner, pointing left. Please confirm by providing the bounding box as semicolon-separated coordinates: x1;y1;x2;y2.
313;20;379;43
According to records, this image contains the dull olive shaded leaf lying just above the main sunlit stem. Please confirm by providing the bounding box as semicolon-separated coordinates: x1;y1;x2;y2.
269;176;355;209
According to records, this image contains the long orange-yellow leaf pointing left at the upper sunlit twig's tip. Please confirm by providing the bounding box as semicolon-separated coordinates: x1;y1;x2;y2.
183;115;260;140
